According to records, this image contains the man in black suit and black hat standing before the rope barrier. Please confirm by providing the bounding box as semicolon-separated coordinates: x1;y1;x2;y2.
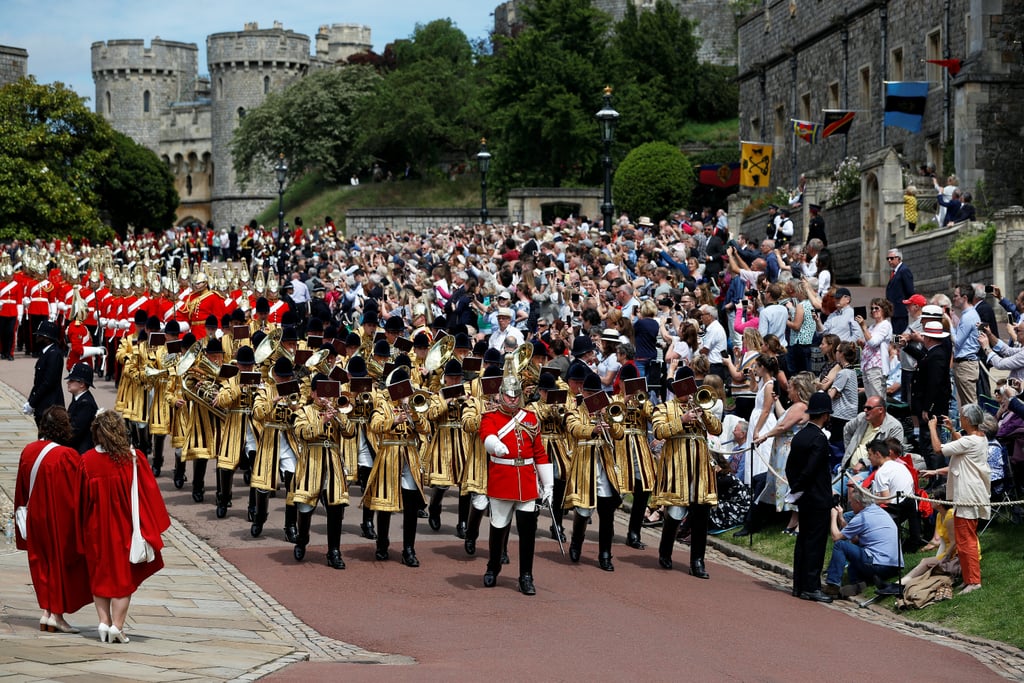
785;391;833;602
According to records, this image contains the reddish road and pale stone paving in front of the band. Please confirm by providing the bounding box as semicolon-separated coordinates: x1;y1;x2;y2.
0;307;1024;681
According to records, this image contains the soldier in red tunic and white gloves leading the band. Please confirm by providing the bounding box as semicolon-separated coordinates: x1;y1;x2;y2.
480;376;554;595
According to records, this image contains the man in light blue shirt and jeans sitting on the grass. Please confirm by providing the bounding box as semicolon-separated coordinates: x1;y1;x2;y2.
824;485;903;597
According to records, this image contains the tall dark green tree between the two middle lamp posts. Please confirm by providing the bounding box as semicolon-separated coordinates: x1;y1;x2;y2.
486;0;614;187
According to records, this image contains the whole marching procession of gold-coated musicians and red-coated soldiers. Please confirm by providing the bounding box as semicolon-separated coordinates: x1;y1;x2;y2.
14;242;721;595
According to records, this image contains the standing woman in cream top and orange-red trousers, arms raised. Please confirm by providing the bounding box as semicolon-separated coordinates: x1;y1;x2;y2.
922;403;991;593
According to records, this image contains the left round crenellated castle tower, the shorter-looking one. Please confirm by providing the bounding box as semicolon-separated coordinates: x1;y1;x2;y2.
92;38;199;154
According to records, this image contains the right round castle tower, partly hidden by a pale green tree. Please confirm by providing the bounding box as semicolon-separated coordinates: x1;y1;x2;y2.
206;23;309;226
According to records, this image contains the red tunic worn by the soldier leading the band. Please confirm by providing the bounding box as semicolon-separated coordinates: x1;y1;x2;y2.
480;411;551;502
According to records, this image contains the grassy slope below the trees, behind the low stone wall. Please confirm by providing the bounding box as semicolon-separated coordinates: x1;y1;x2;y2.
256;173;481;226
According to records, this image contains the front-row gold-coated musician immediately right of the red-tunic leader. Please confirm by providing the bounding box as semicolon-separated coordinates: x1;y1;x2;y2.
563;373;624;571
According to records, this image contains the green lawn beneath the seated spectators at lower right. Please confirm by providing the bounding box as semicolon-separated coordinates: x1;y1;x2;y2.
717;522;1024;647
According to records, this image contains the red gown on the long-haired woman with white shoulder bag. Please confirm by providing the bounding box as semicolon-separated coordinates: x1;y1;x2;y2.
79;449;171;598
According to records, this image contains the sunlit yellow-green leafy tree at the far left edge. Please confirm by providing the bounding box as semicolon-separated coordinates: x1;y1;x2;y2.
0;77;113;240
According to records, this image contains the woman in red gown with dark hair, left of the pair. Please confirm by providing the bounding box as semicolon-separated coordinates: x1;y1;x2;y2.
14;405;92;633
